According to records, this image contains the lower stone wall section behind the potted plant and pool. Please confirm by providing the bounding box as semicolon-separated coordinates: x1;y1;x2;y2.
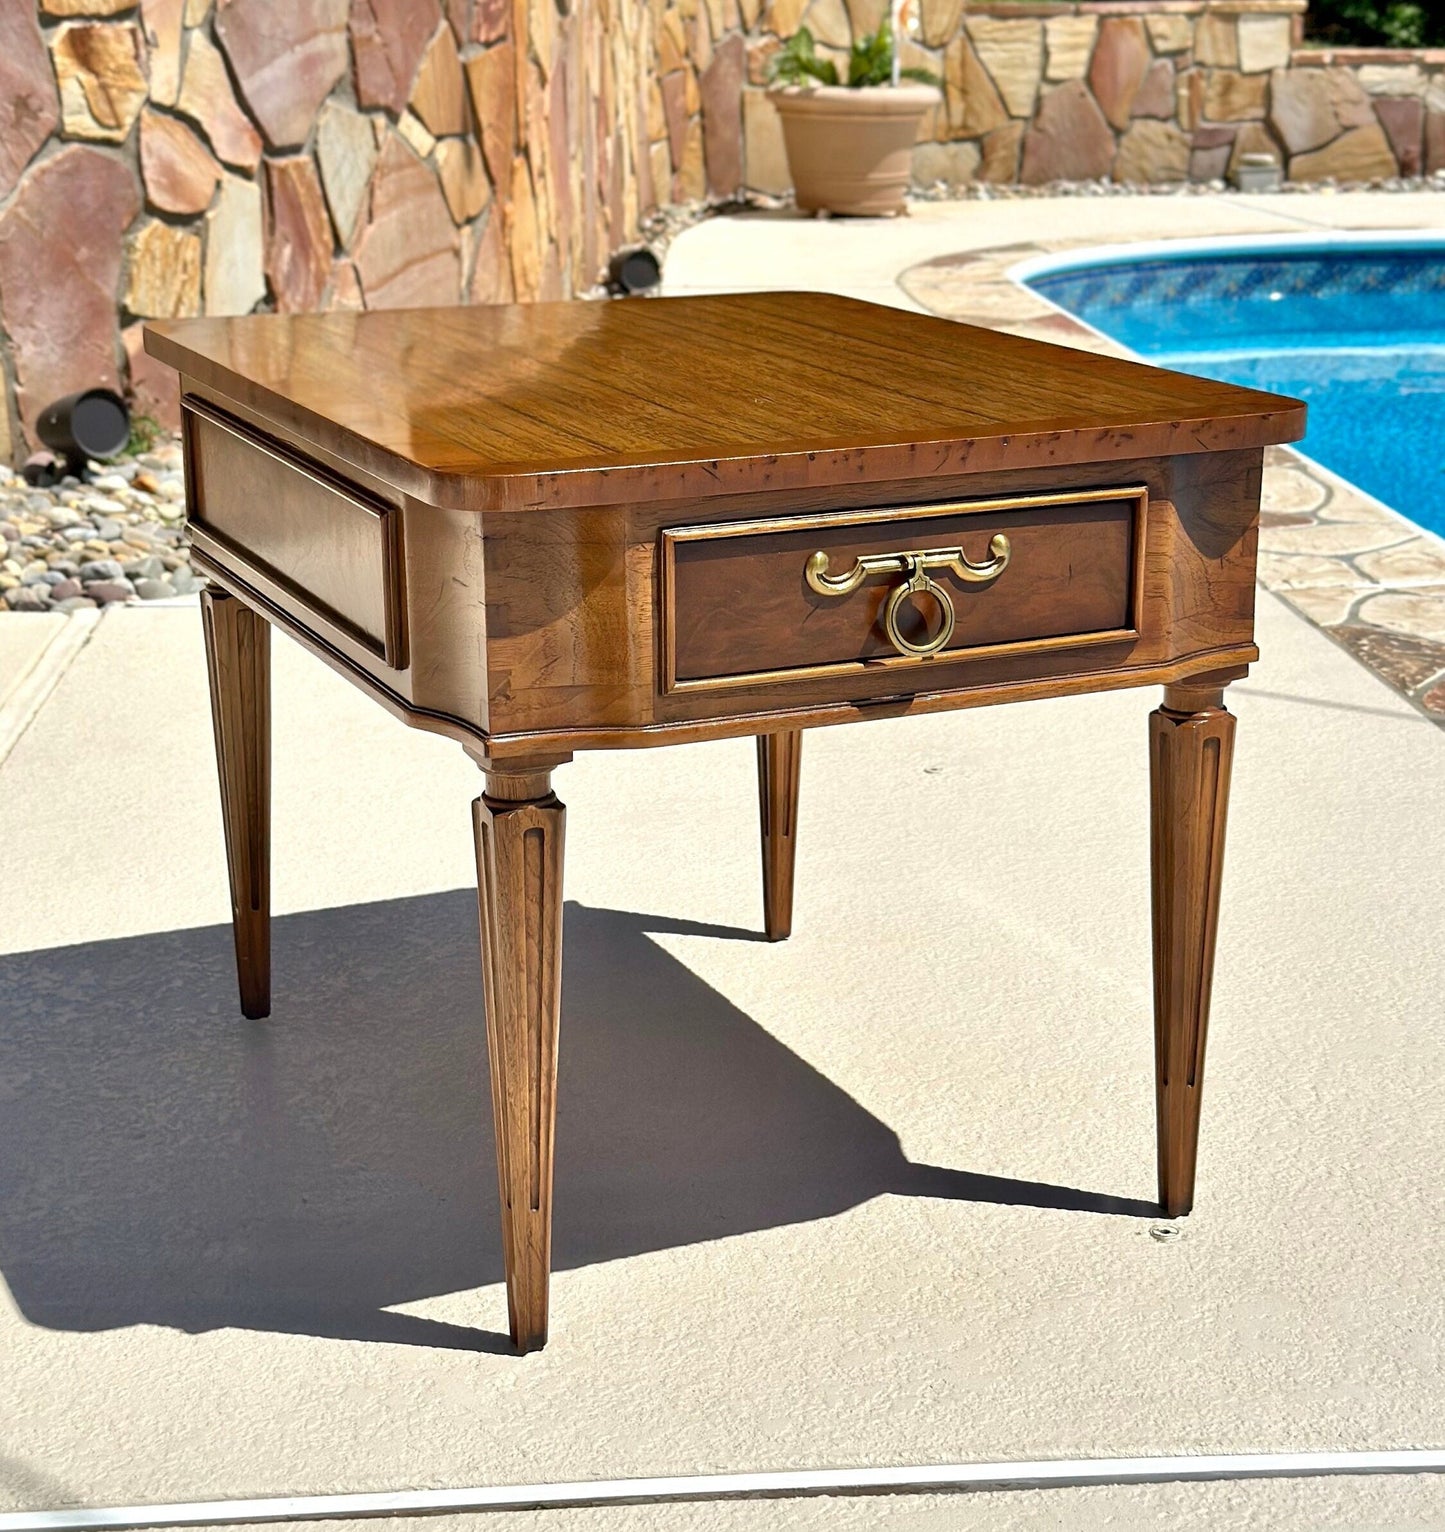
745;0;1445;192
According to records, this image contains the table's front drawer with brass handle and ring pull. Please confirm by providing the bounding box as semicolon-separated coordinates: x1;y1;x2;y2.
662;486;1148;691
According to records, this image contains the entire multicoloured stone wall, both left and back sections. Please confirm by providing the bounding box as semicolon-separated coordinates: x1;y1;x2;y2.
0;0;1445;461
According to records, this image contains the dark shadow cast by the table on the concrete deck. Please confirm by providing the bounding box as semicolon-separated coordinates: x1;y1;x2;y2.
0;892;1157;1350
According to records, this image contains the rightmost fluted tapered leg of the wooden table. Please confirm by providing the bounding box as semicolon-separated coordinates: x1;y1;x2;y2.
1149;686;1235;1218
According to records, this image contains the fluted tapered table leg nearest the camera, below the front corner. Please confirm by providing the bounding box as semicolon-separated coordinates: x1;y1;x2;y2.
472;771;567;1351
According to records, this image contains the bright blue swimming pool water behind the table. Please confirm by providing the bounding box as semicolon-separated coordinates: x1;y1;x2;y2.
1027;239;1445;533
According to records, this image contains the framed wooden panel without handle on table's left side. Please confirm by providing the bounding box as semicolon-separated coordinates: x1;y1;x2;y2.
182;398;405;669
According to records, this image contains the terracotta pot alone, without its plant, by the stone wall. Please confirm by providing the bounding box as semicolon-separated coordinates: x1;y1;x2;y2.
768;84;938;216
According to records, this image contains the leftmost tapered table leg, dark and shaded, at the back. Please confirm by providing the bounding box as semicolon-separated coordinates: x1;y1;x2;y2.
201;587;271;1020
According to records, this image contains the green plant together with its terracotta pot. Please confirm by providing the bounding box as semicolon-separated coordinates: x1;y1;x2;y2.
768;18;939;214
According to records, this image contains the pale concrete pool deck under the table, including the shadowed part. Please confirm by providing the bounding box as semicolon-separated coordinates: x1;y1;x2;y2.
0;196;1445;1532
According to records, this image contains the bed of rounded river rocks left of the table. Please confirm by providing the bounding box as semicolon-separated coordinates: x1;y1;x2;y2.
0;440;205;611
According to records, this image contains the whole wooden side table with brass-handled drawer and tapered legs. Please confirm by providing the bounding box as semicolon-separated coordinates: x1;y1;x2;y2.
146;293;1304;1351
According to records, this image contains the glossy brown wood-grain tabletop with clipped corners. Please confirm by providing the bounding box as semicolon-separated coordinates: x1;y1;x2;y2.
146;293;1304;510
